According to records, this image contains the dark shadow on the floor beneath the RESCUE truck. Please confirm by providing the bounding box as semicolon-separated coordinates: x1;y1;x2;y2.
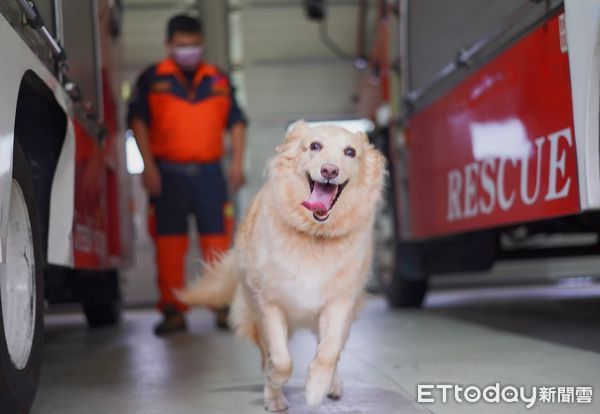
426;286;600;353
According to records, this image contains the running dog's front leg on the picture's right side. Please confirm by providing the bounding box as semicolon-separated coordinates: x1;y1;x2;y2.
306;300;354;408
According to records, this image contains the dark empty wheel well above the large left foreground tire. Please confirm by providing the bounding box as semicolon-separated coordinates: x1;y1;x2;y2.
15;71;67;261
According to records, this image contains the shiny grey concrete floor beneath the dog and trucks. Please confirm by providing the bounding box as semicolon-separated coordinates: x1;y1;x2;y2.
32;287;600;414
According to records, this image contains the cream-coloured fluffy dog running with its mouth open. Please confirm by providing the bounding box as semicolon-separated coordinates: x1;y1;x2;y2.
179;121;385;412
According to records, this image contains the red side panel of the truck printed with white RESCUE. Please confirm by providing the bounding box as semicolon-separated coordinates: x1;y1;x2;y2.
407;15;581;239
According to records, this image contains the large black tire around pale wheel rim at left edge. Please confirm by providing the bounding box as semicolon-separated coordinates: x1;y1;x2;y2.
0;142;44;414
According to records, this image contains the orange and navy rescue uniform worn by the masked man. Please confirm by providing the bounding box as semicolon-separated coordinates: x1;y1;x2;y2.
128;59;247;310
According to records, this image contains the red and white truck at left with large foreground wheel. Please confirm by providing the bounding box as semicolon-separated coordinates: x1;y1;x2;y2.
0;0;131;413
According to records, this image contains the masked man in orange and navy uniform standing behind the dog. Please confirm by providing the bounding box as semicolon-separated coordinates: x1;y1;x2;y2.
128;15;247;335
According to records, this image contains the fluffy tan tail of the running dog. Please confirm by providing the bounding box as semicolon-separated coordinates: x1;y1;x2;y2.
175;250;238;309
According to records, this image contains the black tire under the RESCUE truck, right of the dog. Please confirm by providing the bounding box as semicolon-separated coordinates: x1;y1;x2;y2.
385;242;429;308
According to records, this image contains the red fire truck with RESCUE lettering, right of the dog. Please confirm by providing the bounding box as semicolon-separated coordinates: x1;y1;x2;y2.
371;0;600;306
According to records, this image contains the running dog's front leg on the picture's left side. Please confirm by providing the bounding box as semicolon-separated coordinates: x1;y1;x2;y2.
261;305;292;412
